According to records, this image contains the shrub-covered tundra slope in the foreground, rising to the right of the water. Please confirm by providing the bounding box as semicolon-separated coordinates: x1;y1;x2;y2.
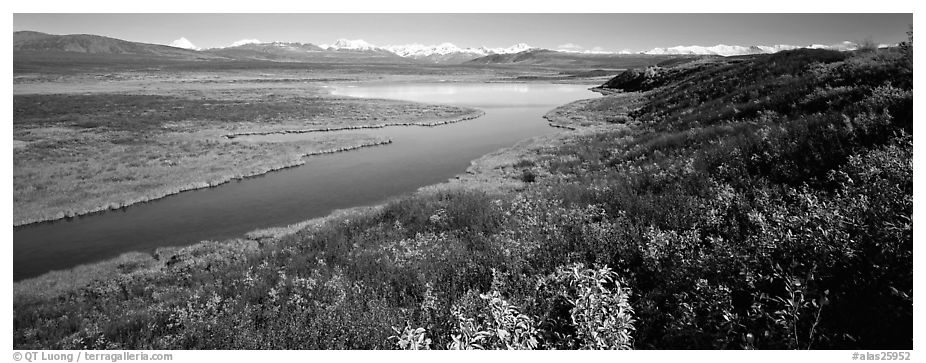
13;47;913;349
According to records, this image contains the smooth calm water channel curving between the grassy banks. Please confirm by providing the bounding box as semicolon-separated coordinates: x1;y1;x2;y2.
13;83;598;281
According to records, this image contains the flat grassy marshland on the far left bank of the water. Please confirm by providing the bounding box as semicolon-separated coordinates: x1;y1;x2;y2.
13;75;481;225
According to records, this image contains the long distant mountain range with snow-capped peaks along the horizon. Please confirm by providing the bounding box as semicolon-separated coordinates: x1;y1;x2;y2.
13;31;884;68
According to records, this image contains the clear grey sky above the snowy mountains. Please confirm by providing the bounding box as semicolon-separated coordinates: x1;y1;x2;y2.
13;14;913;51
